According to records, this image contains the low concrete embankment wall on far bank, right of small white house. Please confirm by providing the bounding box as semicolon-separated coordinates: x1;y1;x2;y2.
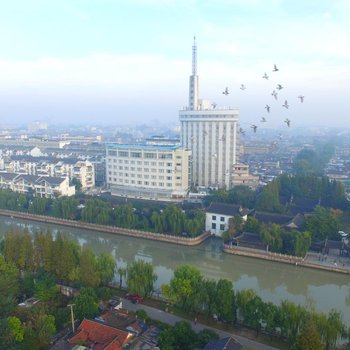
223;244;350;275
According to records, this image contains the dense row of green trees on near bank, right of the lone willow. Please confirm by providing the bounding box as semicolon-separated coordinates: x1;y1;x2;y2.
161;265;350;350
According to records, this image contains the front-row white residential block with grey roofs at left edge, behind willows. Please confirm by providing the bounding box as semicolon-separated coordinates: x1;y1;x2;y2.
0;172;75;198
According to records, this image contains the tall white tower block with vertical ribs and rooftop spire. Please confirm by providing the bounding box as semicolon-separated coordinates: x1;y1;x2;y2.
179;37;239;189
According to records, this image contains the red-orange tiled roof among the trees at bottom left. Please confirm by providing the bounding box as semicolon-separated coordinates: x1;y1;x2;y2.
69;319;129;350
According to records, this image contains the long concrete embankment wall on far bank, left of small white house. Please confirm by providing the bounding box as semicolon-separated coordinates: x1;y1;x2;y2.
0;209;210;246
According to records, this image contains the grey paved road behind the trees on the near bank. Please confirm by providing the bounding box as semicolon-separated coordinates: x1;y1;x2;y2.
123;299;277;350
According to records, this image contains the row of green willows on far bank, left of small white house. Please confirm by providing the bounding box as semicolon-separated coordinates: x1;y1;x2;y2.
0;190;205;237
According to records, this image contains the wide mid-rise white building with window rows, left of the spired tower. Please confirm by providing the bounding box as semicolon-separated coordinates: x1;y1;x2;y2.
106;144;191;199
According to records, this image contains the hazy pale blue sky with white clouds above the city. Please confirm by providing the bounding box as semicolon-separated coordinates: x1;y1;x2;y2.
0;0;350;127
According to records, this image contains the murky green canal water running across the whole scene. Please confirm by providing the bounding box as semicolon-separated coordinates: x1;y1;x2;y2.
0;217;350;326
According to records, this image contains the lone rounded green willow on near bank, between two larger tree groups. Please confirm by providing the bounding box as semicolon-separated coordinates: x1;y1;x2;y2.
127;260;157;297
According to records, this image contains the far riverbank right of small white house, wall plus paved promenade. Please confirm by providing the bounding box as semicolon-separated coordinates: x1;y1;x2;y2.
223;244;350;275
